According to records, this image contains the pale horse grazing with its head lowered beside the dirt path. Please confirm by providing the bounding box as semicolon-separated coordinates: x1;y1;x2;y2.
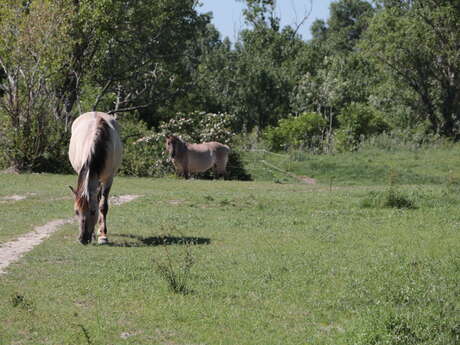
69;112;122;244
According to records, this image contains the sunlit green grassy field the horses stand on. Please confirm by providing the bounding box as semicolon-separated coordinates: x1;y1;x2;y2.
0;147;460;345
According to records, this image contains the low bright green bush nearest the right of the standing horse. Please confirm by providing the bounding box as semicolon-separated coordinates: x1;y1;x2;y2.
264;113;327;151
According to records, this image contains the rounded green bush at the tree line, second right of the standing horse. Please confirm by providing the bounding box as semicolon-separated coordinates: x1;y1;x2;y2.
334;103;390;152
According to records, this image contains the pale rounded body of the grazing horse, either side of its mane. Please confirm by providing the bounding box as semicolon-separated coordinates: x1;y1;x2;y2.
69;112;122;177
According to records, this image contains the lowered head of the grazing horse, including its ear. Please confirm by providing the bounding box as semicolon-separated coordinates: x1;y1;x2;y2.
69;186;99;244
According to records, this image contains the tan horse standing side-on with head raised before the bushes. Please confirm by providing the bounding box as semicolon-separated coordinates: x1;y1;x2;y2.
166;135;230;179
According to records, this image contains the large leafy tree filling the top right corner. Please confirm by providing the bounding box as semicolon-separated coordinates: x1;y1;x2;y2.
361;0;460;137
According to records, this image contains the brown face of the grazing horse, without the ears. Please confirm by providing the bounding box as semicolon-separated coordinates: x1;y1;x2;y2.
74;197;99;244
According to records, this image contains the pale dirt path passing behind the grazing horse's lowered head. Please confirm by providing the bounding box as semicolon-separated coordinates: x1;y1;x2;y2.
0;195;140;274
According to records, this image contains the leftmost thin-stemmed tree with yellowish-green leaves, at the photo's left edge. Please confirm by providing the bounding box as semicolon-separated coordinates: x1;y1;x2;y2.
0;0;72;171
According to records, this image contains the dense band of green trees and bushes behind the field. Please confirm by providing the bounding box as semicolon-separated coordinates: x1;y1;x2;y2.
0;0;460;171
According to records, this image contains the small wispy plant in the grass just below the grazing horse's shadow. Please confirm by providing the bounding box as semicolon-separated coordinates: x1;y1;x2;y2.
154;238;195;295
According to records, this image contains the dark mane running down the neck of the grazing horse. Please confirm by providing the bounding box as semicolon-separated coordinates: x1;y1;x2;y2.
76;117;110;209
